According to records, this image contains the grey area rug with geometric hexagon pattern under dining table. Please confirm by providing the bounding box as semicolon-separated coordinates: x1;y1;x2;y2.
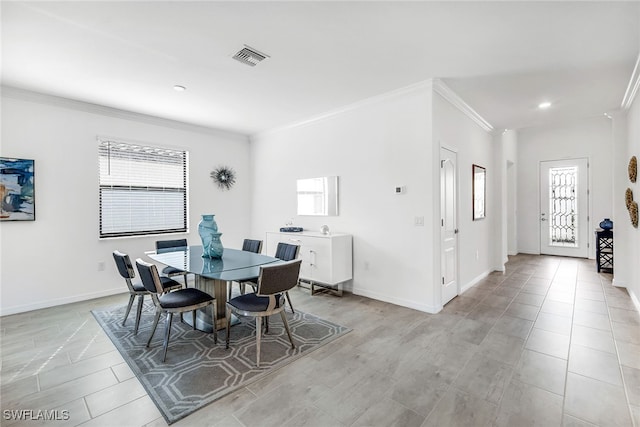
92;302;350;424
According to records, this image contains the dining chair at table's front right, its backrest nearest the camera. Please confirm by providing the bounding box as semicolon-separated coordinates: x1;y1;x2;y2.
226;260;302;367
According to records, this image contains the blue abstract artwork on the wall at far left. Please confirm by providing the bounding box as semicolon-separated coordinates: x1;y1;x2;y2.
0;157;36;221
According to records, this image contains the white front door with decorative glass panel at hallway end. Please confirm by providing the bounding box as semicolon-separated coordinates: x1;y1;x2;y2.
540;159;589;258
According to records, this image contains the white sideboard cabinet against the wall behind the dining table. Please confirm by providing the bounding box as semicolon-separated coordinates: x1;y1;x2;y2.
266;231;353;294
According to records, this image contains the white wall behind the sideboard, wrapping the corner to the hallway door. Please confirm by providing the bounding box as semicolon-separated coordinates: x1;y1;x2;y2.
251;82;490;312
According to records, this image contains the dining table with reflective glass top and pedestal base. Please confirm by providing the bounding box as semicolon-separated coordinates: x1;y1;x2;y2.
145;246;282;332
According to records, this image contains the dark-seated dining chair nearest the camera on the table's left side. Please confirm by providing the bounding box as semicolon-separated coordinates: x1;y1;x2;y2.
136;258;218;362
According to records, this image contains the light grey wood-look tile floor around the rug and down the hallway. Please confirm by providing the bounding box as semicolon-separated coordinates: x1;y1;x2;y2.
0;255;640;427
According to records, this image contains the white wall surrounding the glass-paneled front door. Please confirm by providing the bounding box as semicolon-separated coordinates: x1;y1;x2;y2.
517;116;615;258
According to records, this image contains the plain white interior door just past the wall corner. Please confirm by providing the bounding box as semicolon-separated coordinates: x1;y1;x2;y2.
440;148;458;305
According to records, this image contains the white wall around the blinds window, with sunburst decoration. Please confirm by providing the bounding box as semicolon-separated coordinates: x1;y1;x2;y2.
0;90;251;315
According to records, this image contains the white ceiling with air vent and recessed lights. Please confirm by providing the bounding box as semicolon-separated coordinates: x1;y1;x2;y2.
0;1;640;134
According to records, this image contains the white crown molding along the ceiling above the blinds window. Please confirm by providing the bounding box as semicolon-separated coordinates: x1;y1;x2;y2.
0;85;248;140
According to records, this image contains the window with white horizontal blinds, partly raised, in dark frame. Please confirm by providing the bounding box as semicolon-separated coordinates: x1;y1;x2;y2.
98;138;188;238
